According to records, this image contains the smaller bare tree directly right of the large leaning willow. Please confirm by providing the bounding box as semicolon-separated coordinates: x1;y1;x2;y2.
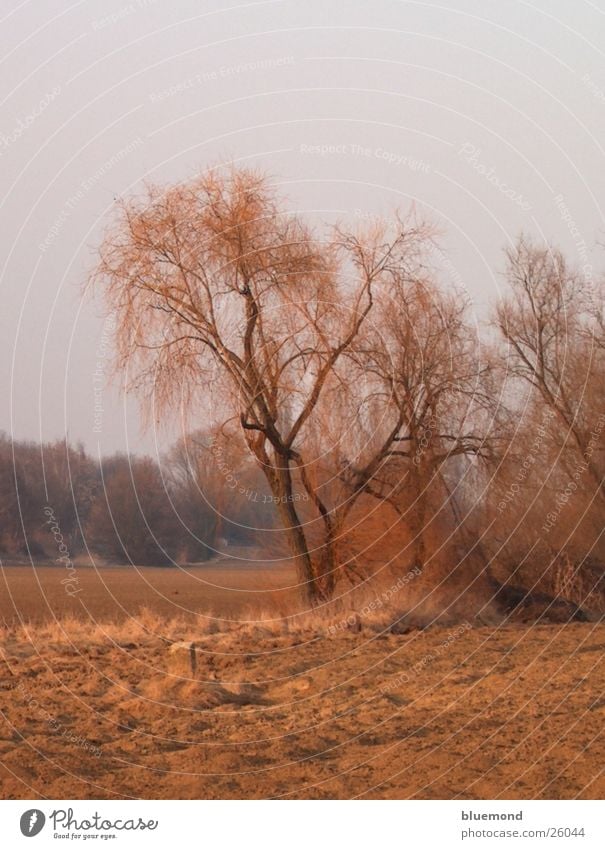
356;260;496;569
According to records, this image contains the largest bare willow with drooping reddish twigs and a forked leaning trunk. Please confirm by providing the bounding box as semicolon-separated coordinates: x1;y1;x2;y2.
91;169;425;602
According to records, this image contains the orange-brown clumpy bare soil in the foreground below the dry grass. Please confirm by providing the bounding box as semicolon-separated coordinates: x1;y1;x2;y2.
0;624;605;799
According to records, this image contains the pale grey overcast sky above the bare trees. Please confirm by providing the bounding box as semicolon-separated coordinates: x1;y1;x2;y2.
0;0;605;460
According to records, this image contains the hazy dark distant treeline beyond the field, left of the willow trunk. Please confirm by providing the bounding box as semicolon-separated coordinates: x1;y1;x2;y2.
0;433;276;565
